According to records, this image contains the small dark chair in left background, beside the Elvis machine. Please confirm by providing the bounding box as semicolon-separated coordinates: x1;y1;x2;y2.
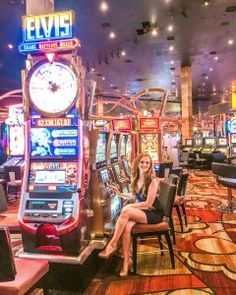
4;166;22;199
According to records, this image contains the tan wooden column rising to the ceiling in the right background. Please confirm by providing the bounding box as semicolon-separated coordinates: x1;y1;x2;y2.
181;67;193;143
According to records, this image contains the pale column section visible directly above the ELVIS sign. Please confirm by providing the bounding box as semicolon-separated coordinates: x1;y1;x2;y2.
26;0;54;15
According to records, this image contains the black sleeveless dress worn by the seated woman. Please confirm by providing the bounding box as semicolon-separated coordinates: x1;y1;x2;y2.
136;184;164;224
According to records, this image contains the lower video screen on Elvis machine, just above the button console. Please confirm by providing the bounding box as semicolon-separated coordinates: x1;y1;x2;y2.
28;162;78;192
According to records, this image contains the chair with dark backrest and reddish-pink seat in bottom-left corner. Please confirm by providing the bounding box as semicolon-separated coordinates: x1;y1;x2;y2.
0;227;49;295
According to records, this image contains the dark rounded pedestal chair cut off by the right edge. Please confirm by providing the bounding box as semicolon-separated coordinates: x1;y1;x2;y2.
211;162;236;212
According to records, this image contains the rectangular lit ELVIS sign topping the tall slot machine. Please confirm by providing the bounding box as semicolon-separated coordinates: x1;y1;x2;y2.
22;11;73;42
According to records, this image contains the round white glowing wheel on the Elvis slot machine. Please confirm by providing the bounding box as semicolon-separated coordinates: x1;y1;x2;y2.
25;60;79;116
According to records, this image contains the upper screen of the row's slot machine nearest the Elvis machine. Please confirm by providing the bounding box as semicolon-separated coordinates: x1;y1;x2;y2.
96;132;109;169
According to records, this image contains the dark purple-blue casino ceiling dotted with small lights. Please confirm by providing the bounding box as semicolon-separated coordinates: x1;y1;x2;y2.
0;0;236;113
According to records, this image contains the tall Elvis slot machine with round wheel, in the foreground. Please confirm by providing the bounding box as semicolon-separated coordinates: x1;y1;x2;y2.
19;11;89;256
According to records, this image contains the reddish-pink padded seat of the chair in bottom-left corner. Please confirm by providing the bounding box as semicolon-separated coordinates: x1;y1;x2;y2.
0;258;49;295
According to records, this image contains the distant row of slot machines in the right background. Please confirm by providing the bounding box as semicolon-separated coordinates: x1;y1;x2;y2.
182;136;233;157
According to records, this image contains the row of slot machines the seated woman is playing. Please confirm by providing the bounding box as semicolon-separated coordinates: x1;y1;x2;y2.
90;129;134;236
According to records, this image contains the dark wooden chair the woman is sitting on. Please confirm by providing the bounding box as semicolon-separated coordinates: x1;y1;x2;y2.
132;181;176;273
